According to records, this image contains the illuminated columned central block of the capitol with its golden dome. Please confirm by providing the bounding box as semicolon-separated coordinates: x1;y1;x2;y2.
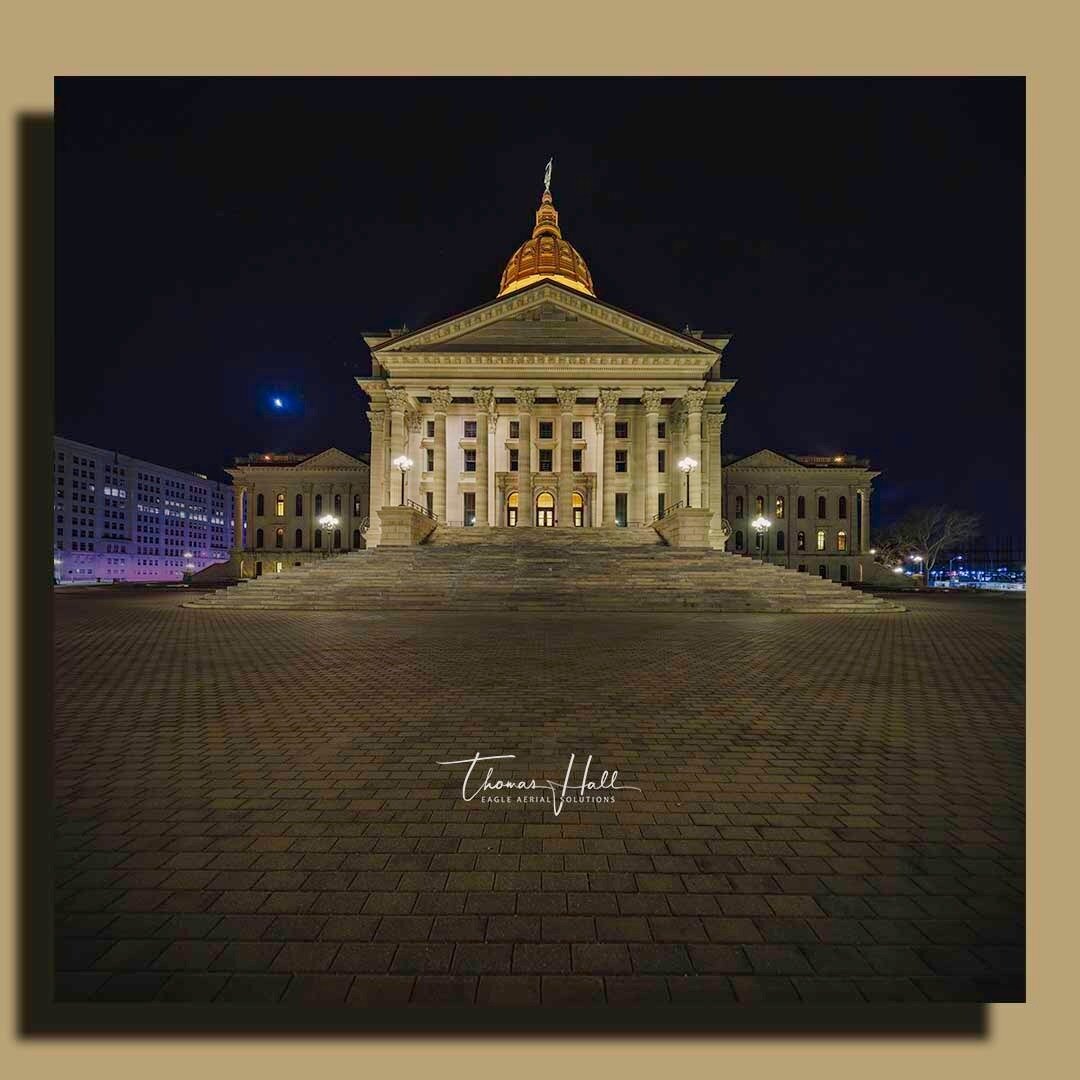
356;183;734;546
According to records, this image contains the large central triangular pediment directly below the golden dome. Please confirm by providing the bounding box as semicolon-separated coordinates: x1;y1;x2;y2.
374;282;726;359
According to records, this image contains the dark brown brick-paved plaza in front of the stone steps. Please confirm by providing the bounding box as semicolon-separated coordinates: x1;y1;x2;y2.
54;583;1024;1007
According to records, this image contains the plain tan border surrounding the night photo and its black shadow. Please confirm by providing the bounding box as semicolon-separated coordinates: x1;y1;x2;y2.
0;0;1067;1080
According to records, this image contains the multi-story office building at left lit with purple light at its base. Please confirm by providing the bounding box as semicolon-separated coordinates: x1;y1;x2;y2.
53;436;232;583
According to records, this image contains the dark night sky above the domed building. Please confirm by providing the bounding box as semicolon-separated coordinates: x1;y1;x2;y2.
56;78;1025;541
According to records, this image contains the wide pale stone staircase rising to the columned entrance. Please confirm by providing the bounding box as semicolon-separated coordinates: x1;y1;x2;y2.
184;525;904;612
